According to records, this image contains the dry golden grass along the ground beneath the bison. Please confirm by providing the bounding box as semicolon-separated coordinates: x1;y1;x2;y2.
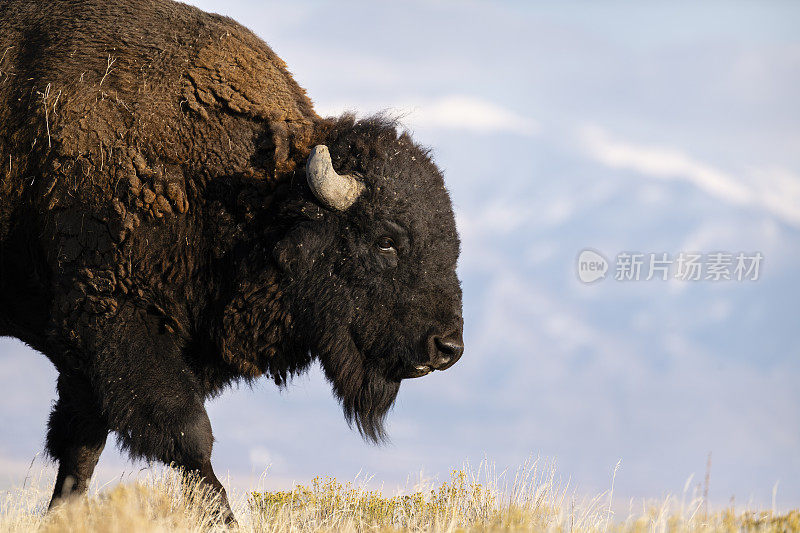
0;462;800;533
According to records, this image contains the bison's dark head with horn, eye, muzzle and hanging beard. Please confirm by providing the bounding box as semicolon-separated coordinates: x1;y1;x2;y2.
277;117;464;441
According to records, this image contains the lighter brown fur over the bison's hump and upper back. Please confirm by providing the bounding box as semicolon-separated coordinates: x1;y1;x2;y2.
0;0;319;240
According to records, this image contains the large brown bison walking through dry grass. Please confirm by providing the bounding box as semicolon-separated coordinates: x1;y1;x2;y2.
0;0;463;519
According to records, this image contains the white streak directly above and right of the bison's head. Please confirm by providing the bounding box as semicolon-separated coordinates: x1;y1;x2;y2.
317;95;539;136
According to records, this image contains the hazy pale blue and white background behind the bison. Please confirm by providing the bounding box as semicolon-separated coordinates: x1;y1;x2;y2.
0;0;800;507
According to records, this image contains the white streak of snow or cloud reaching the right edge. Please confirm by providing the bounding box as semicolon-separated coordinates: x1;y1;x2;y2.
580;125;800;226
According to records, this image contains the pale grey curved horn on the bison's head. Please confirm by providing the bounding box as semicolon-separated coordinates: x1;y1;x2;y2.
306;144;364;211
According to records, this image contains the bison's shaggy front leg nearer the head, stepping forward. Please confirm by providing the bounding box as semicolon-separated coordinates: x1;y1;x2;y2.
95;310;234;523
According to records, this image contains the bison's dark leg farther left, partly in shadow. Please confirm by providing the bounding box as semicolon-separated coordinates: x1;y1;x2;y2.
47;374;108;508
